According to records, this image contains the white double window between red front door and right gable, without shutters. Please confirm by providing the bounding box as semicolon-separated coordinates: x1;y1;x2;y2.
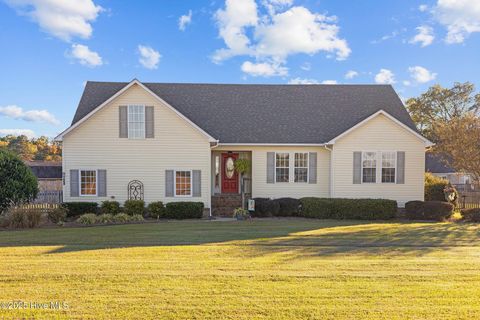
275;152;308;183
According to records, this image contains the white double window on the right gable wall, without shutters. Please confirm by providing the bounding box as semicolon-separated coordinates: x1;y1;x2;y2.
362;151;397;183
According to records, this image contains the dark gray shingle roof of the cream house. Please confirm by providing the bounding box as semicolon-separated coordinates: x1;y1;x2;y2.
72;81;416;143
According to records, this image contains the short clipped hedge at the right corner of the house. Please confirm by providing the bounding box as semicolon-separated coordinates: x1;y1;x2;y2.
405;201;455;221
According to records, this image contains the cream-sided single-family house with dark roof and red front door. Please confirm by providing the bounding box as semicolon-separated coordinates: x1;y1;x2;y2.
57;79;431;209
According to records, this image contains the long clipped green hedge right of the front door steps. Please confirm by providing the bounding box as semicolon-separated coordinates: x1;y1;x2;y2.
252;198;397;220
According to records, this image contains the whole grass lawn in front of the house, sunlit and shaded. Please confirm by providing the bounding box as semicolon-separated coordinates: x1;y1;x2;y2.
0;219;480;319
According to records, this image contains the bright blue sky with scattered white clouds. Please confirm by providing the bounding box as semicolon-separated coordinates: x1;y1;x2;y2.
0;0;480;137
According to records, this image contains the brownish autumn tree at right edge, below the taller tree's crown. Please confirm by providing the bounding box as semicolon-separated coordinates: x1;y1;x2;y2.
434;112;480;182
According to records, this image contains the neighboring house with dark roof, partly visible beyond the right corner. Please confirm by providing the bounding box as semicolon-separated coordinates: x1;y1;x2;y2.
425;152;473;185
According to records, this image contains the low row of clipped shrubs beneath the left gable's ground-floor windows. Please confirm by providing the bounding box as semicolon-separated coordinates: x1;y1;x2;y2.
62;200;204;219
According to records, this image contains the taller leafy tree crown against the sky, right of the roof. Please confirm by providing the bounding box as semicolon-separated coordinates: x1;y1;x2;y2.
406;82;480;142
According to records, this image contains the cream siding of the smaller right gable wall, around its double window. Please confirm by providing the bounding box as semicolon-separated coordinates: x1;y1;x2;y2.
332;115;425;206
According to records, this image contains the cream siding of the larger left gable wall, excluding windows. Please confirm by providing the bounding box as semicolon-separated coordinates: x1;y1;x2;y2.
62;85;211;208
